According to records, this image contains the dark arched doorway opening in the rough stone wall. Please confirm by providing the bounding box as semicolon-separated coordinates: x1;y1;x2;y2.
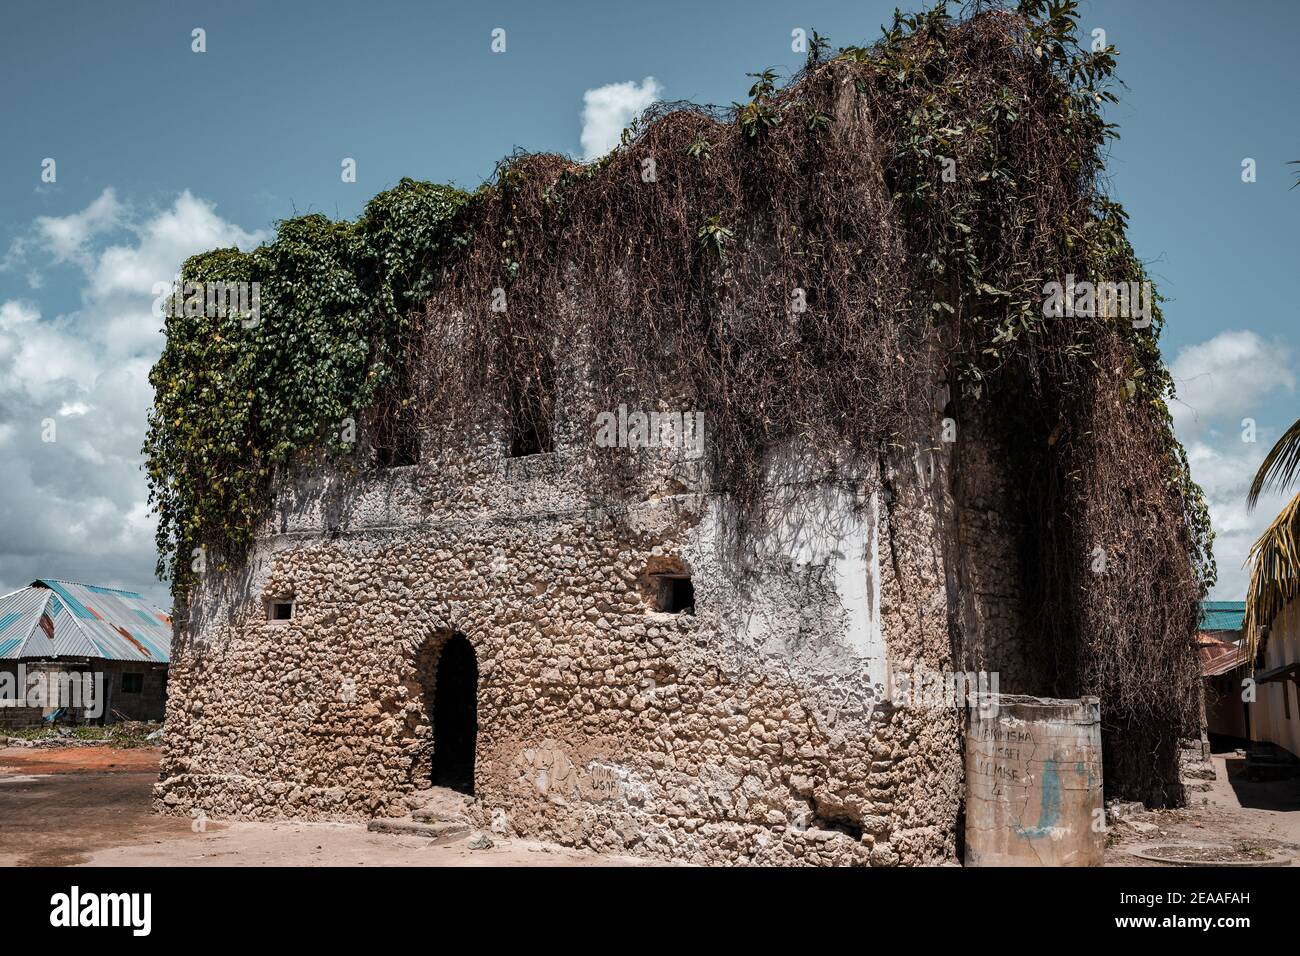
433;633;478;795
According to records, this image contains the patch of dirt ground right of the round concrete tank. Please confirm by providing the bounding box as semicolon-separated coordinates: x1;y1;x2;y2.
1106;753;1300;866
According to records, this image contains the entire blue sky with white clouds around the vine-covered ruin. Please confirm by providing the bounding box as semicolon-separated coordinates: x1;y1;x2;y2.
0;0;1300;601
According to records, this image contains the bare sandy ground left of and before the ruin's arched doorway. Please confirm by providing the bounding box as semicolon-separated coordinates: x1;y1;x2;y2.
0;747;644;866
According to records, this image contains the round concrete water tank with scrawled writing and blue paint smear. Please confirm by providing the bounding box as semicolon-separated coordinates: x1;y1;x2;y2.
966;695;1106;866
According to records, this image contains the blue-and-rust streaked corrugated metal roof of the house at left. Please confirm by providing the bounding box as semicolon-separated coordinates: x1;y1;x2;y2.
0;580;172;663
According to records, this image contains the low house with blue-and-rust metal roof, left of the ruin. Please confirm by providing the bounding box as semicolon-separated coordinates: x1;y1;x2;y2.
0;580;172;728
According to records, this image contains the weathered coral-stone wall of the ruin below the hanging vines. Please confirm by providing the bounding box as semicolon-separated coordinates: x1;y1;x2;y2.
157;368;1041;865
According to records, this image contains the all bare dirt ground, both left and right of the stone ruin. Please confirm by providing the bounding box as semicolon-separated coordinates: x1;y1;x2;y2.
0;747;1300;866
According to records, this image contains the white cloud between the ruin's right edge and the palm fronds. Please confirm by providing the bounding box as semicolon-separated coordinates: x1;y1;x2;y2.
1170;330;1296;600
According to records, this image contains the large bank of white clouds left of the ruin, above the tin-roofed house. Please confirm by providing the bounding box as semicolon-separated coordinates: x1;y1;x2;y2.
0;190;265;606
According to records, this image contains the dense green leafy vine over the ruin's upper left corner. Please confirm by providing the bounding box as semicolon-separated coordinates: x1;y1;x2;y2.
143;179;468;592
